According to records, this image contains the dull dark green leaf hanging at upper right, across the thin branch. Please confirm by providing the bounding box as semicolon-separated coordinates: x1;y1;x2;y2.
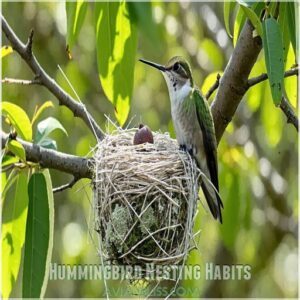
263;18;284;105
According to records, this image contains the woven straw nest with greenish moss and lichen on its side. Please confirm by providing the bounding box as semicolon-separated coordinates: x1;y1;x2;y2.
93;129;199;278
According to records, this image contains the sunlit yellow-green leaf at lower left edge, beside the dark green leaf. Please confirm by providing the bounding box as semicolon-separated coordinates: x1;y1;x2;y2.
1;171;28;298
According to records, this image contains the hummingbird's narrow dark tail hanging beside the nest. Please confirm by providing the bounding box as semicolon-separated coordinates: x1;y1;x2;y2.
201;178;223;223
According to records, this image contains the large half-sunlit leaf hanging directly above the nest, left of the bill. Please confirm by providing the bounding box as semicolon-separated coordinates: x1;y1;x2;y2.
95;1;137;126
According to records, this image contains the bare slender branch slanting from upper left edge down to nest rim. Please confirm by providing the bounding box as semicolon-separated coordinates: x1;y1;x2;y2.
1;15;104;140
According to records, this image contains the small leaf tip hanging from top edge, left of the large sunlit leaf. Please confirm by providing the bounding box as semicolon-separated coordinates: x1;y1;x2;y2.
66;0;88;48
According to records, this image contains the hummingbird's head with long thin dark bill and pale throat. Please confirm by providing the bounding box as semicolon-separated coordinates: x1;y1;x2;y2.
140;56;194;99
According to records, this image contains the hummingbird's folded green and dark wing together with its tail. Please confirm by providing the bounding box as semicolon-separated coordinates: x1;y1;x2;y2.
193;89;223;223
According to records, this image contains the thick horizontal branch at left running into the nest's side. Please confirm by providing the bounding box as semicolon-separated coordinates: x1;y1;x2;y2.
1;132;92;179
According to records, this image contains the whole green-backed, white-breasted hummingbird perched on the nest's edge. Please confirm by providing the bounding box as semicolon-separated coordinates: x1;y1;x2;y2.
140;56;224;223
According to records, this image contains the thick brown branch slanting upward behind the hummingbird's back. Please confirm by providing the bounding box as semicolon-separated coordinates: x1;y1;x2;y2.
211;21;262;142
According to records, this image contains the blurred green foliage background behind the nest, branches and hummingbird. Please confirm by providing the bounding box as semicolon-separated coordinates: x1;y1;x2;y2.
2;2;298;298
